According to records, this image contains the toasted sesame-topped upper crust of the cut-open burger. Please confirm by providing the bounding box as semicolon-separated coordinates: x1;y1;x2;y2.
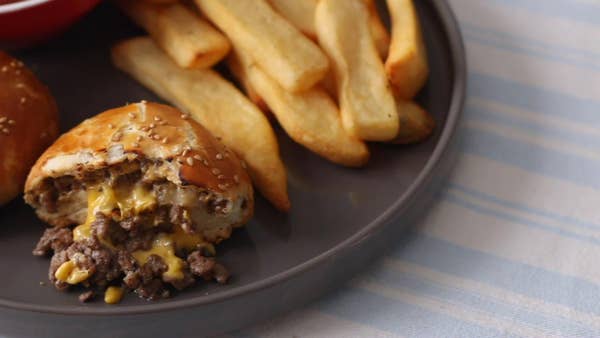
25;101;252;197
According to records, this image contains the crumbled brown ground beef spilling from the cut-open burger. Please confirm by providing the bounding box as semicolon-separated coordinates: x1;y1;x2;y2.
33;207;229;302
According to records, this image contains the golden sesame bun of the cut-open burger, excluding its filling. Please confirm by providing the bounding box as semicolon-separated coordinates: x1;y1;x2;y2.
25;101;254;239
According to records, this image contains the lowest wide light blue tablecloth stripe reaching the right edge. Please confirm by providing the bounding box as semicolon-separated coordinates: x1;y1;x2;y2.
391;233;600;315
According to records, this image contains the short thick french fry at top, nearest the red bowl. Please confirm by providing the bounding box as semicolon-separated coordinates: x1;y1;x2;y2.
117;0;231;68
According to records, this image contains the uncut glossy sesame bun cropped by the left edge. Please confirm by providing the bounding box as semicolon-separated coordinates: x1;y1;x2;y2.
0;51;58;205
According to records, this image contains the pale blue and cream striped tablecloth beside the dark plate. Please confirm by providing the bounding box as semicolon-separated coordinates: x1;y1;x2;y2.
230;0;600;338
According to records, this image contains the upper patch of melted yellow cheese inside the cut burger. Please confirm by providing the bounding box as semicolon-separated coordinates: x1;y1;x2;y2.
73;184;156;242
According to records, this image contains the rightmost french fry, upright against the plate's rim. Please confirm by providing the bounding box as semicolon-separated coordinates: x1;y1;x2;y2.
385;0;429;100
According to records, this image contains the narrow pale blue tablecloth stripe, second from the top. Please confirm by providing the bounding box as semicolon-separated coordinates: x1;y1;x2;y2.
460;21;600;60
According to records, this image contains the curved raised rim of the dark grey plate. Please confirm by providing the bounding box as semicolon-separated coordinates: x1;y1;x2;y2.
0;0;467;316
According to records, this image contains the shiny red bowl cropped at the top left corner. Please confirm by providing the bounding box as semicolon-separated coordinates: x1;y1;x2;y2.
0;0;101;48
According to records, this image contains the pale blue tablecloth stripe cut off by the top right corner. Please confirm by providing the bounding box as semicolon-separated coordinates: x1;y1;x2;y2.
492;0;600;25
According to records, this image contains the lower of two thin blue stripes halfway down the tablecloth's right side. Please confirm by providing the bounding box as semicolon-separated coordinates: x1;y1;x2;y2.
442;192;600;245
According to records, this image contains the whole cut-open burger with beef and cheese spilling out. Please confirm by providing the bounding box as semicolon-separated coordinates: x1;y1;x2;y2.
25;102;254;303
